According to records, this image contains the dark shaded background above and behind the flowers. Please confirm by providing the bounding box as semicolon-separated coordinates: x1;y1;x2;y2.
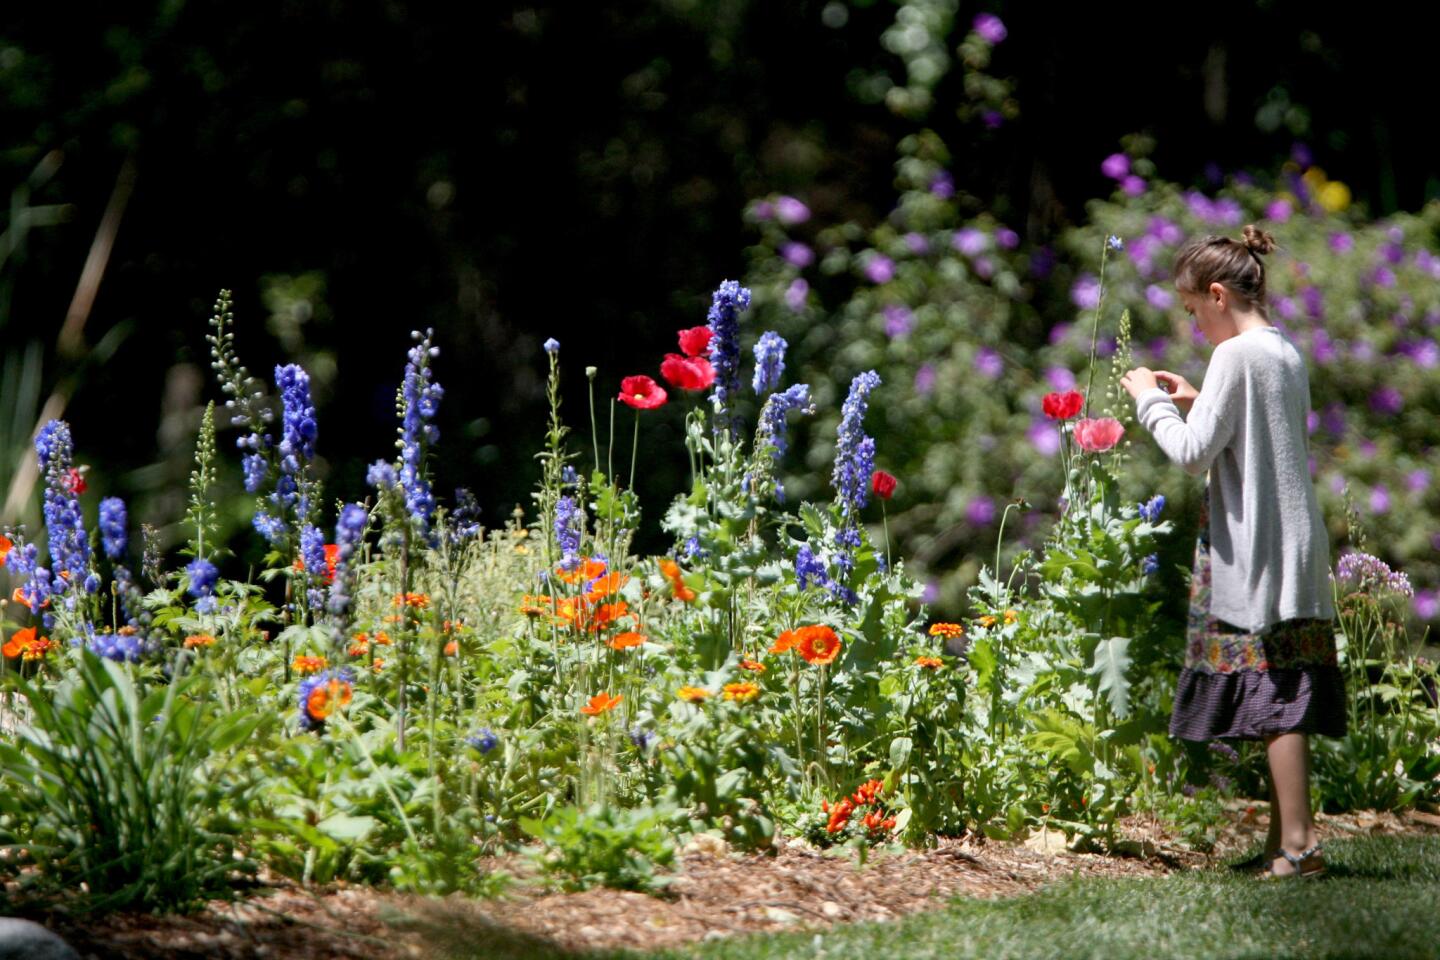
0;0;1440;555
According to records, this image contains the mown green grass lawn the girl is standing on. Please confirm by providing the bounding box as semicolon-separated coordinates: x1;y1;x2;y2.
432;836;1440;960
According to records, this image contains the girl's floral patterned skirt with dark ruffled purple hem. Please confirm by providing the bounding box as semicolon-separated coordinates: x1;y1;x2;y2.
1171;495;1345;741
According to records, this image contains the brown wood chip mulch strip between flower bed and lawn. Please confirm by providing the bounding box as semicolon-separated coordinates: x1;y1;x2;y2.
39;803;1440;960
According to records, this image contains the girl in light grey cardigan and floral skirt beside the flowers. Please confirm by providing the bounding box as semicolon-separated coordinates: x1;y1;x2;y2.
1120;226;1345;877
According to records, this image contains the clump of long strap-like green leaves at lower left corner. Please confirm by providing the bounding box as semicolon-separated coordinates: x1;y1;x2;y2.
0;651;264;910
